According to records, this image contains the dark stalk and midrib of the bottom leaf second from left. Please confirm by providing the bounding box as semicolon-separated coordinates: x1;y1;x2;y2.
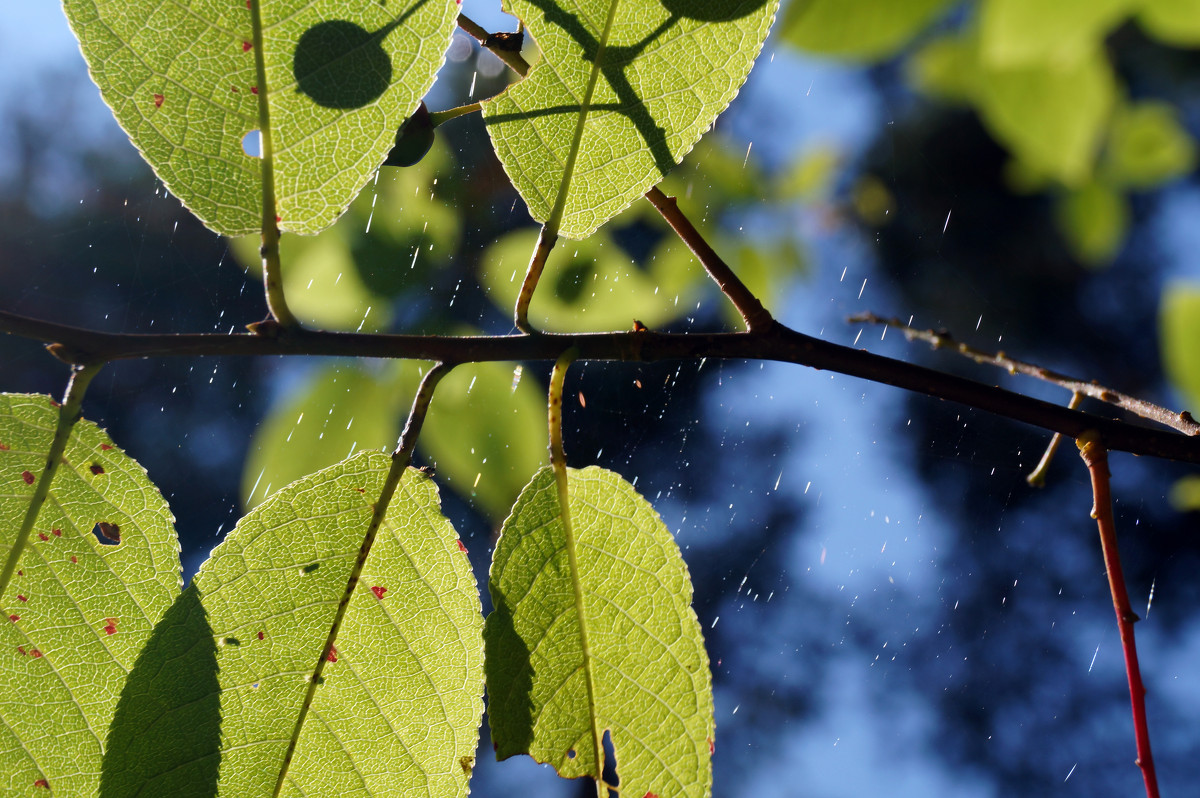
274;362;452;796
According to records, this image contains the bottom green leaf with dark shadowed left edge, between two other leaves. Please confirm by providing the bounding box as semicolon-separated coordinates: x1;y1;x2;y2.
106;452;482;797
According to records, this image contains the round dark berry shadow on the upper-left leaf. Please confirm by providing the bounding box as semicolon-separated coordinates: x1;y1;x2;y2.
292;20;393;108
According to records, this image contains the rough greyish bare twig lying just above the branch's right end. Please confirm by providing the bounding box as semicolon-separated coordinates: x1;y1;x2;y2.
847;313;1200;436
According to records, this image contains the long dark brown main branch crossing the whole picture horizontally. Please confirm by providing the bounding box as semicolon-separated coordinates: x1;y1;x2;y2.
7;311;1200;463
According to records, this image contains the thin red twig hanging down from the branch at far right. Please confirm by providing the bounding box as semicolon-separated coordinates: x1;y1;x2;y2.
1075;432;1158;798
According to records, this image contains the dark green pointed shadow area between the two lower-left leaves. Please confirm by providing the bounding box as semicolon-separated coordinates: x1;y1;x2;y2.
98;586;221;798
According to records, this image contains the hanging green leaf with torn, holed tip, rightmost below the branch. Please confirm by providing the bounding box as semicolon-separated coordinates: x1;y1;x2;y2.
484;467;714;797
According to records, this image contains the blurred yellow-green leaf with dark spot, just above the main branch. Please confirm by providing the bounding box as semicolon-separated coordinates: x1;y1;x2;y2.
480;229;700;328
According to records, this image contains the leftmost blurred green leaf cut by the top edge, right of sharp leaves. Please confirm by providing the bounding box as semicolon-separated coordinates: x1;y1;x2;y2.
780;0;952;61
